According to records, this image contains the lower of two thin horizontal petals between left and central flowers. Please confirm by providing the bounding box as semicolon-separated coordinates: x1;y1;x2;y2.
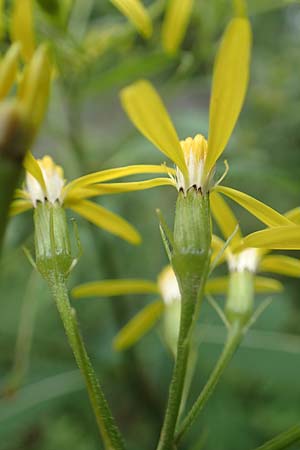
65;178;174;204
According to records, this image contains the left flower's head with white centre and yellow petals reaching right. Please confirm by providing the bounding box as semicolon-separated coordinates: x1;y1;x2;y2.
11;153;175;244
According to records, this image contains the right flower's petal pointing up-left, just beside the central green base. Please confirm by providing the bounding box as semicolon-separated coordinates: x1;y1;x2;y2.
210;191;242;245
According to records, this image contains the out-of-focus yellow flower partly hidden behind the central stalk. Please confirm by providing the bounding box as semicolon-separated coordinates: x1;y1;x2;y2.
72;265;282;354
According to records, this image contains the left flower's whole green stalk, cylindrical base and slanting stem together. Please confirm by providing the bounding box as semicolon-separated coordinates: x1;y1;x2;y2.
34;202;125;450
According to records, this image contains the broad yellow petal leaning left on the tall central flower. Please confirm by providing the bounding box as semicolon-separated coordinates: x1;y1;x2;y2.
121;80;187;175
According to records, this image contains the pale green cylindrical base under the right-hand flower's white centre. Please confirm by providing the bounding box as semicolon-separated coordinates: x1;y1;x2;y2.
225;270;254;325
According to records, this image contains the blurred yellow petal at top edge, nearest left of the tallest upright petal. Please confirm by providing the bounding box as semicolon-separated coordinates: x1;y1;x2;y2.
162;0;194;54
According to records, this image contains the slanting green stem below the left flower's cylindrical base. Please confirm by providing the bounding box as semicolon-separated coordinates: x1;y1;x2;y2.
49;273;125;450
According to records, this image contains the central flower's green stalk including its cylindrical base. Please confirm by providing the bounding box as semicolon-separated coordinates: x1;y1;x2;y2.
157;187;211;450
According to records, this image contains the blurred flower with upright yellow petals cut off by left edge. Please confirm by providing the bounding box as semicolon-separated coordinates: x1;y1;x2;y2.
0;43;52;155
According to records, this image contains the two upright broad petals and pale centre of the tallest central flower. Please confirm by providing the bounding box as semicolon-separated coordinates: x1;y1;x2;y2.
121;18;251;193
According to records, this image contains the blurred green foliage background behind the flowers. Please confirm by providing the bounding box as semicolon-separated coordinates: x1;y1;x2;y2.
0;0;300;450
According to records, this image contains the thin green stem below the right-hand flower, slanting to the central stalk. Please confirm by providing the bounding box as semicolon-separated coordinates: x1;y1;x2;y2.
175;321;243;444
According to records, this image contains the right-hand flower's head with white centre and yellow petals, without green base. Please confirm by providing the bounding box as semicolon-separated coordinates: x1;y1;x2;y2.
211;192;300;283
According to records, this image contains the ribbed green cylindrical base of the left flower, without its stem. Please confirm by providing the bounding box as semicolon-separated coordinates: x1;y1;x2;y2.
34;201;73;281
